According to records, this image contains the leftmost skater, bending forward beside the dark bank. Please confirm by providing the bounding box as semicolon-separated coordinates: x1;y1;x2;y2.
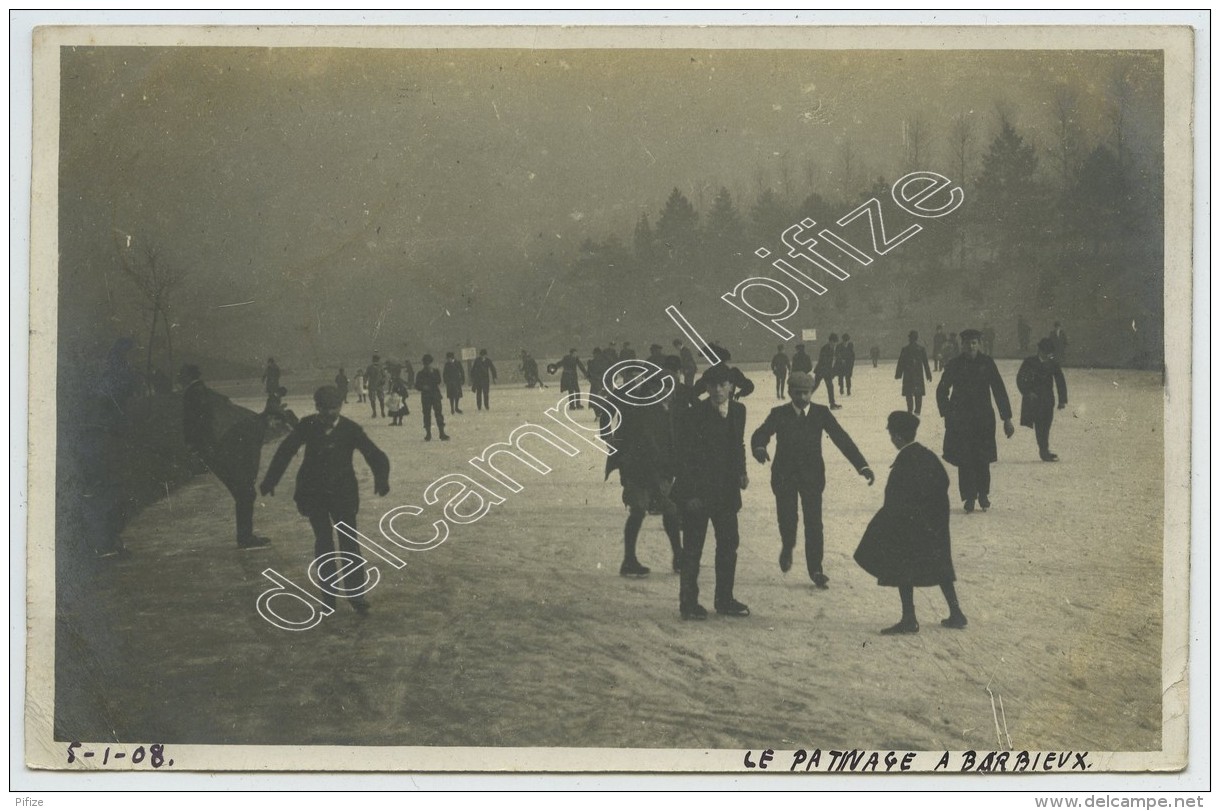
178;363;272;550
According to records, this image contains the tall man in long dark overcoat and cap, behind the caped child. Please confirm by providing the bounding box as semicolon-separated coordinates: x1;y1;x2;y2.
936;329;1016;512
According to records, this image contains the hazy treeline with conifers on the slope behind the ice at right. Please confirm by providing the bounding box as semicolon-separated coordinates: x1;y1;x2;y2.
553;104;1164;366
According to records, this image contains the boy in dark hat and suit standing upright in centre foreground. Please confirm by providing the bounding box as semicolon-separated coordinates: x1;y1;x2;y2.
673;363;750;620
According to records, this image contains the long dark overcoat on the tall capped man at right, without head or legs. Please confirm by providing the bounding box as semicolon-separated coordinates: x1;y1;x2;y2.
936;352;1013;465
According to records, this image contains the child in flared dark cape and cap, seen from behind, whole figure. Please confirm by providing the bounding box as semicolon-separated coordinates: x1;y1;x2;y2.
855;411;966;635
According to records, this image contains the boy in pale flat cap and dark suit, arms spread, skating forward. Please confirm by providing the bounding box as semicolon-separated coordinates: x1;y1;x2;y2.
750;372;874;589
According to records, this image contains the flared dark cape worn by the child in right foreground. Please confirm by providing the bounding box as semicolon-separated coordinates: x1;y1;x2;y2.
855;443;955;587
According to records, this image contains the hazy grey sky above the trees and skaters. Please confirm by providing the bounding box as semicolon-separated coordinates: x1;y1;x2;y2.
60;48;1163;354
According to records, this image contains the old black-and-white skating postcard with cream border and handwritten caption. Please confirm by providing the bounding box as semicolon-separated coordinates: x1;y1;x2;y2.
23;17;1194;788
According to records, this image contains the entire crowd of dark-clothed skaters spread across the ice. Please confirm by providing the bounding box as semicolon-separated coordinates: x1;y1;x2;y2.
90;317;1068;634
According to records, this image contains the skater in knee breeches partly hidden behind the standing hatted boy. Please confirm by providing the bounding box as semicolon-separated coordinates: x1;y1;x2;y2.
606;361;682;577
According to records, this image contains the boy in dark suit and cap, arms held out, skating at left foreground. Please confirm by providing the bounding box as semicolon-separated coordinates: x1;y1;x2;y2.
259;385;389;615
